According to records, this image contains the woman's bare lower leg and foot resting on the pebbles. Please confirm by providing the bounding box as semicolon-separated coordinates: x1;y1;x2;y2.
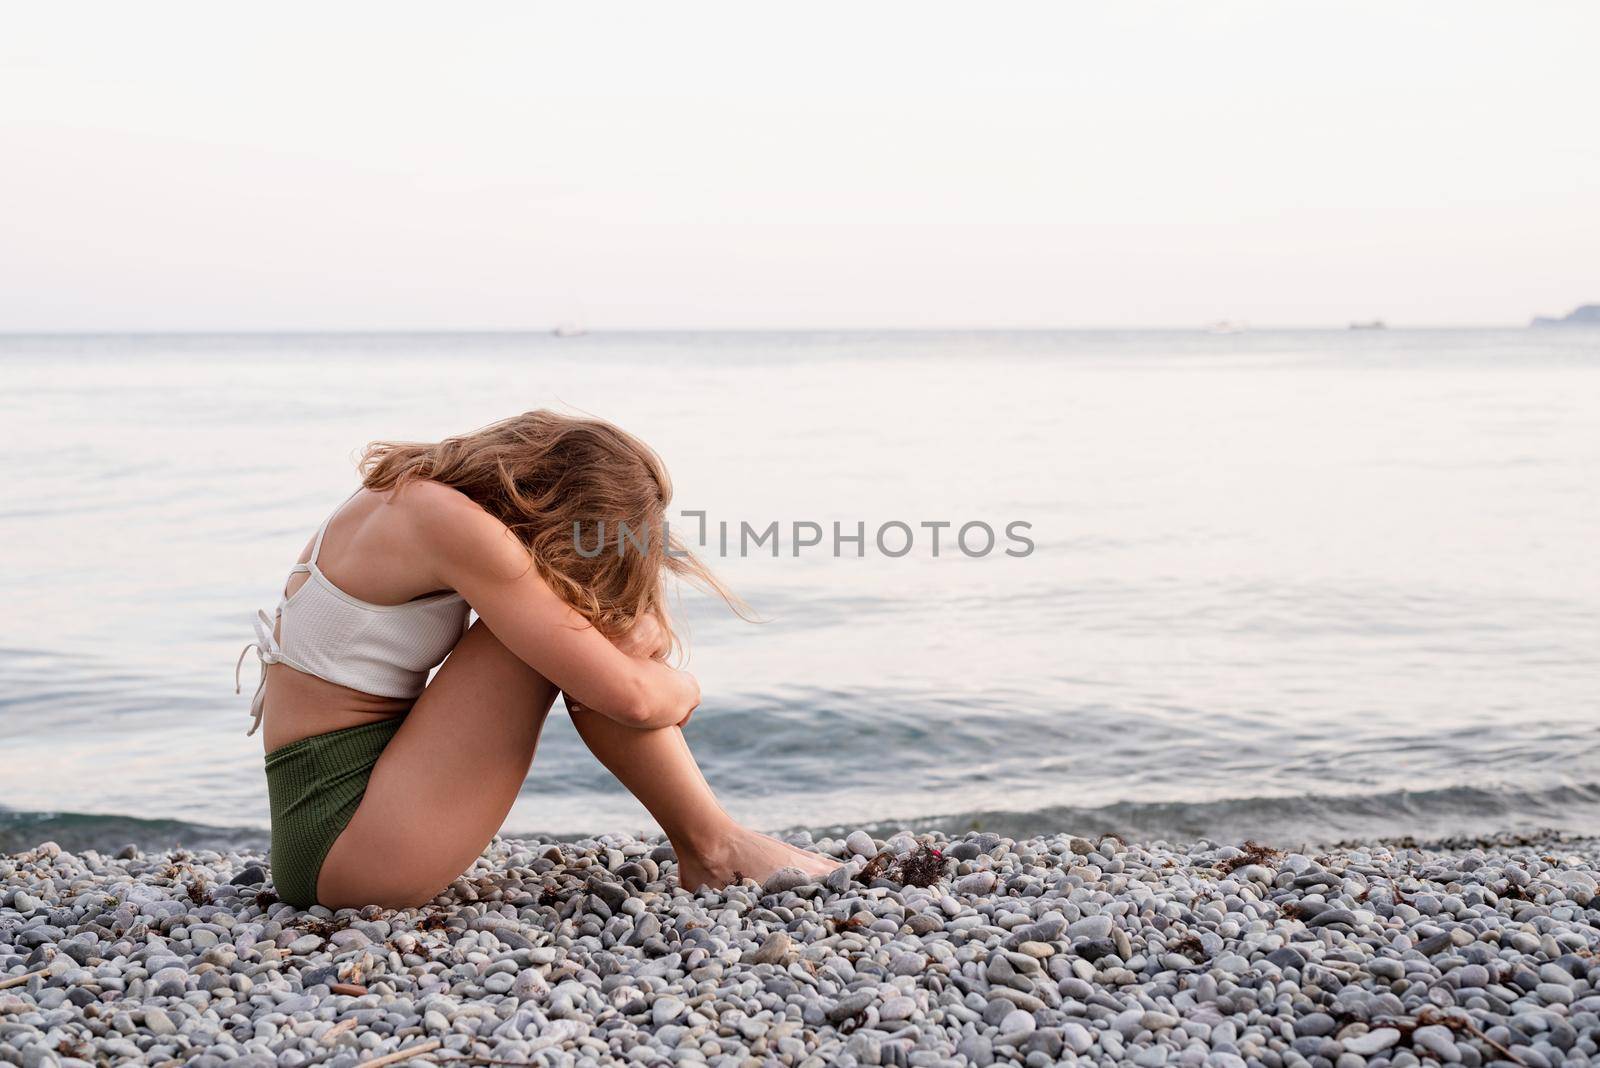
571;708;838;889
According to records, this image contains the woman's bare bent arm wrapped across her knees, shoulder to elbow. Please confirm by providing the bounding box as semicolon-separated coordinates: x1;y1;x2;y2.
403;483;699;727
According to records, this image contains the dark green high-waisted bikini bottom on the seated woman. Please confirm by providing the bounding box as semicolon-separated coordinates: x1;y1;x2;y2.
267;716;405;908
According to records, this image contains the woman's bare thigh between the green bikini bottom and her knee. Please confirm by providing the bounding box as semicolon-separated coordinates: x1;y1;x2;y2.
317;622;555;908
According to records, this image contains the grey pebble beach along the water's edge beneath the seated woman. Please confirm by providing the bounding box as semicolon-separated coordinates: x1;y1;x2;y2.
0;831;1600;1068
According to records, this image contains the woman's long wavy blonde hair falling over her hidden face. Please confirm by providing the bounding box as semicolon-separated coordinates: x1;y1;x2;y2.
360;408;749;652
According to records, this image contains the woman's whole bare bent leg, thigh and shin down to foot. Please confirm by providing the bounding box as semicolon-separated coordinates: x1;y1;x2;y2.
317;622;837;908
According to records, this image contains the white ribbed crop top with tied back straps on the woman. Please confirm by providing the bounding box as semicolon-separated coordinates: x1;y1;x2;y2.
234;491;470;735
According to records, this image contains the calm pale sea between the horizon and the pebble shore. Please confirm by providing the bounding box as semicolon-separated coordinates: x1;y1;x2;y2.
0;331;1600;849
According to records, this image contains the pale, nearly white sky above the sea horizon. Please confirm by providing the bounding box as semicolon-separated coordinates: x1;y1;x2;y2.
0;0;1600;331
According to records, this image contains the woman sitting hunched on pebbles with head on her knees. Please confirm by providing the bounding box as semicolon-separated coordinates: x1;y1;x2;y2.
235;411;834;908
